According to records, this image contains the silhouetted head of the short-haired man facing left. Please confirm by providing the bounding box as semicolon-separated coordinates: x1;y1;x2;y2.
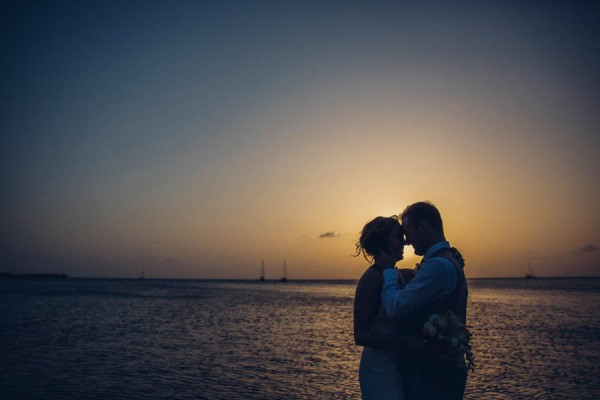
400;201;446;256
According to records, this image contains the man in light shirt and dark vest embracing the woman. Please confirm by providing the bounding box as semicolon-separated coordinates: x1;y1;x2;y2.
377;202;468;400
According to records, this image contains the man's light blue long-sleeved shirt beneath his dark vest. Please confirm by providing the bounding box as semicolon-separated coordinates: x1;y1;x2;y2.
381;242;458;318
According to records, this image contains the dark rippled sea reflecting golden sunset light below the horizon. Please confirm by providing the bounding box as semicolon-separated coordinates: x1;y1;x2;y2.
0;278;600;400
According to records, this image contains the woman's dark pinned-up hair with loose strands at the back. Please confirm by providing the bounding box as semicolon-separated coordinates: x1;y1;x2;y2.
354;215;400;263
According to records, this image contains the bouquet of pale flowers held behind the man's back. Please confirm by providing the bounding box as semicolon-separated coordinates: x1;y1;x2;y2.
421;310;475;371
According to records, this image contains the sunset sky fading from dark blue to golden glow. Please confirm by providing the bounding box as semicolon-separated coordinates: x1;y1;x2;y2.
0;1;600;279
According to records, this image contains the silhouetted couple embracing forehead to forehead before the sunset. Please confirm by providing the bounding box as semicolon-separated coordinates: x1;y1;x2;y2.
354;202;473;400
